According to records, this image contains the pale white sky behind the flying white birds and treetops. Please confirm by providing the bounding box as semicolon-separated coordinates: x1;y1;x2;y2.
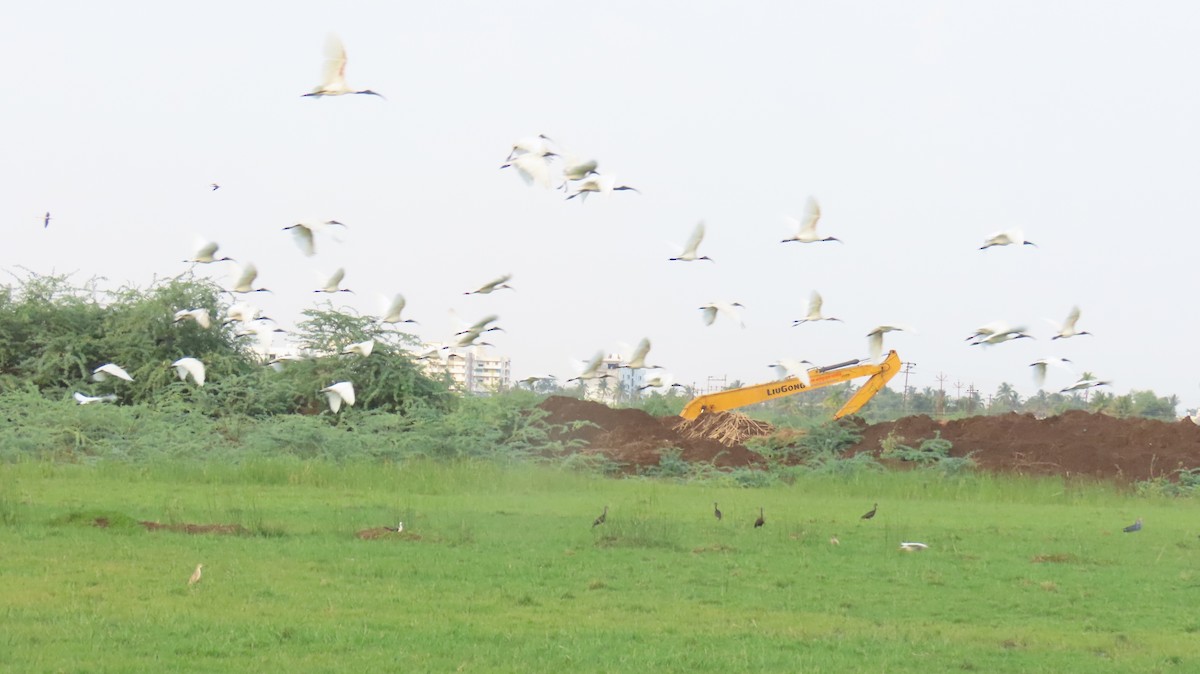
0;1;1200;411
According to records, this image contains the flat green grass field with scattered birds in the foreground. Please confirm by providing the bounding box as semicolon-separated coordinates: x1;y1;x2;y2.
0;459;1200;674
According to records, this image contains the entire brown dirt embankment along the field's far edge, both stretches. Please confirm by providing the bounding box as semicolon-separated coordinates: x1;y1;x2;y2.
540;396;1200;481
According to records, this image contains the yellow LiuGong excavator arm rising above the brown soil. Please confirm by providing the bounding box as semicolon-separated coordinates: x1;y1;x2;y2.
679;351;900;420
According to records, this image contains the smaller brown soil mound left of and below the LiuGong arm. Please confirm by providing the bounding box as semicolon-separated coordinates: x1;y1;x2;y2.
538;396;762;471
